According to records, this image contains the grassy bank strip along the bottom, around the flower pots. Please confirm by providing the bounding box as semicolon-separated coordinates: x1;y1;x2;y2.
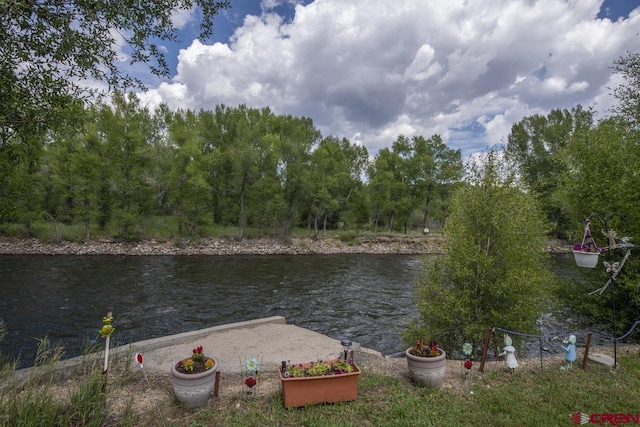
0;348;640;427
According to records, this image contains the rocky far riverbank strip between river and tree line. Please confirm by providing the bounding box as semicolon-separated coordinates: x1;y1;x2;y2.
0;236;570;256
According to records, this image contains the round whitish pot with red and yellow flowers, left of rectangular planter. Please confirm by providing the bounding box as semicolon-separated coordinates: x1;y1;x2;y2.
171;346;218;408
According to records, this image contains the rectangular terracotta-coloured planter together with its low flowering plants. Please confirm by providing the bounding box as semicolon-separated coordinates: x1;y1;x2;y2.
278;359;360;408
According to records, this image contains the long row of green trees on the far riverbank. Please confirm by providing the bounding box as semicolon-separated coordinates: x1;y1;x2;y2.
0;93;463;240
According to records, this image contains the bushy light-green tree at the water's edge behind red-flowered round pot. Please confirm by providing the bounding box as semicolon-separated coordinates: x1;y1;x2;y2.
404;152;552;349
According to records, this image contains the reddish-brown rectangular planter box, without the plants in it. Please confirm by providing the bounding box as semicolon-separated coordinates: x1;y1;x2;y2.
278;361;360;408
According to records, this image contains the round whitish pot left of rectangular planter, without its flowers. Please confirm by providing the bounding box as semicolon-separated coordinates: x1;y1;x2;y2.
171;357;218;408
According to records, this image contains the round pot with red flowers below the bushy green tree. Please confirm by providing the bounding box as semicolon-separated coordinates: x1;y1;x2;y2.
405;340;447;388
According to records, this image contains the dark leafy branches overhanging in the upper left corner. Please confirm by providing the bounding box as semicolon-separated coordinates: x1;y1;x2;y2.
0;0;230;139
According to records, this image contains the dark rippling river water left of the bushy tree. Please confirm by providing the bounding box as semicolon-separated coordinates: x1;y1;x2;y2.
0;255;422;366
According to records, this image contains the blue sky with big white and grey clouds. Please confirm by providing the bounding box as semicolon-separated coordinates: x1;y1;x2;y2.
138;0;640;158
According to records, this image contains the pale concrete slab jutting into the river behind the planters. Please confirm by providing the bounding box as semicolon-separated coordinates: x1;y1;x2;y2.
12;316;370;382
